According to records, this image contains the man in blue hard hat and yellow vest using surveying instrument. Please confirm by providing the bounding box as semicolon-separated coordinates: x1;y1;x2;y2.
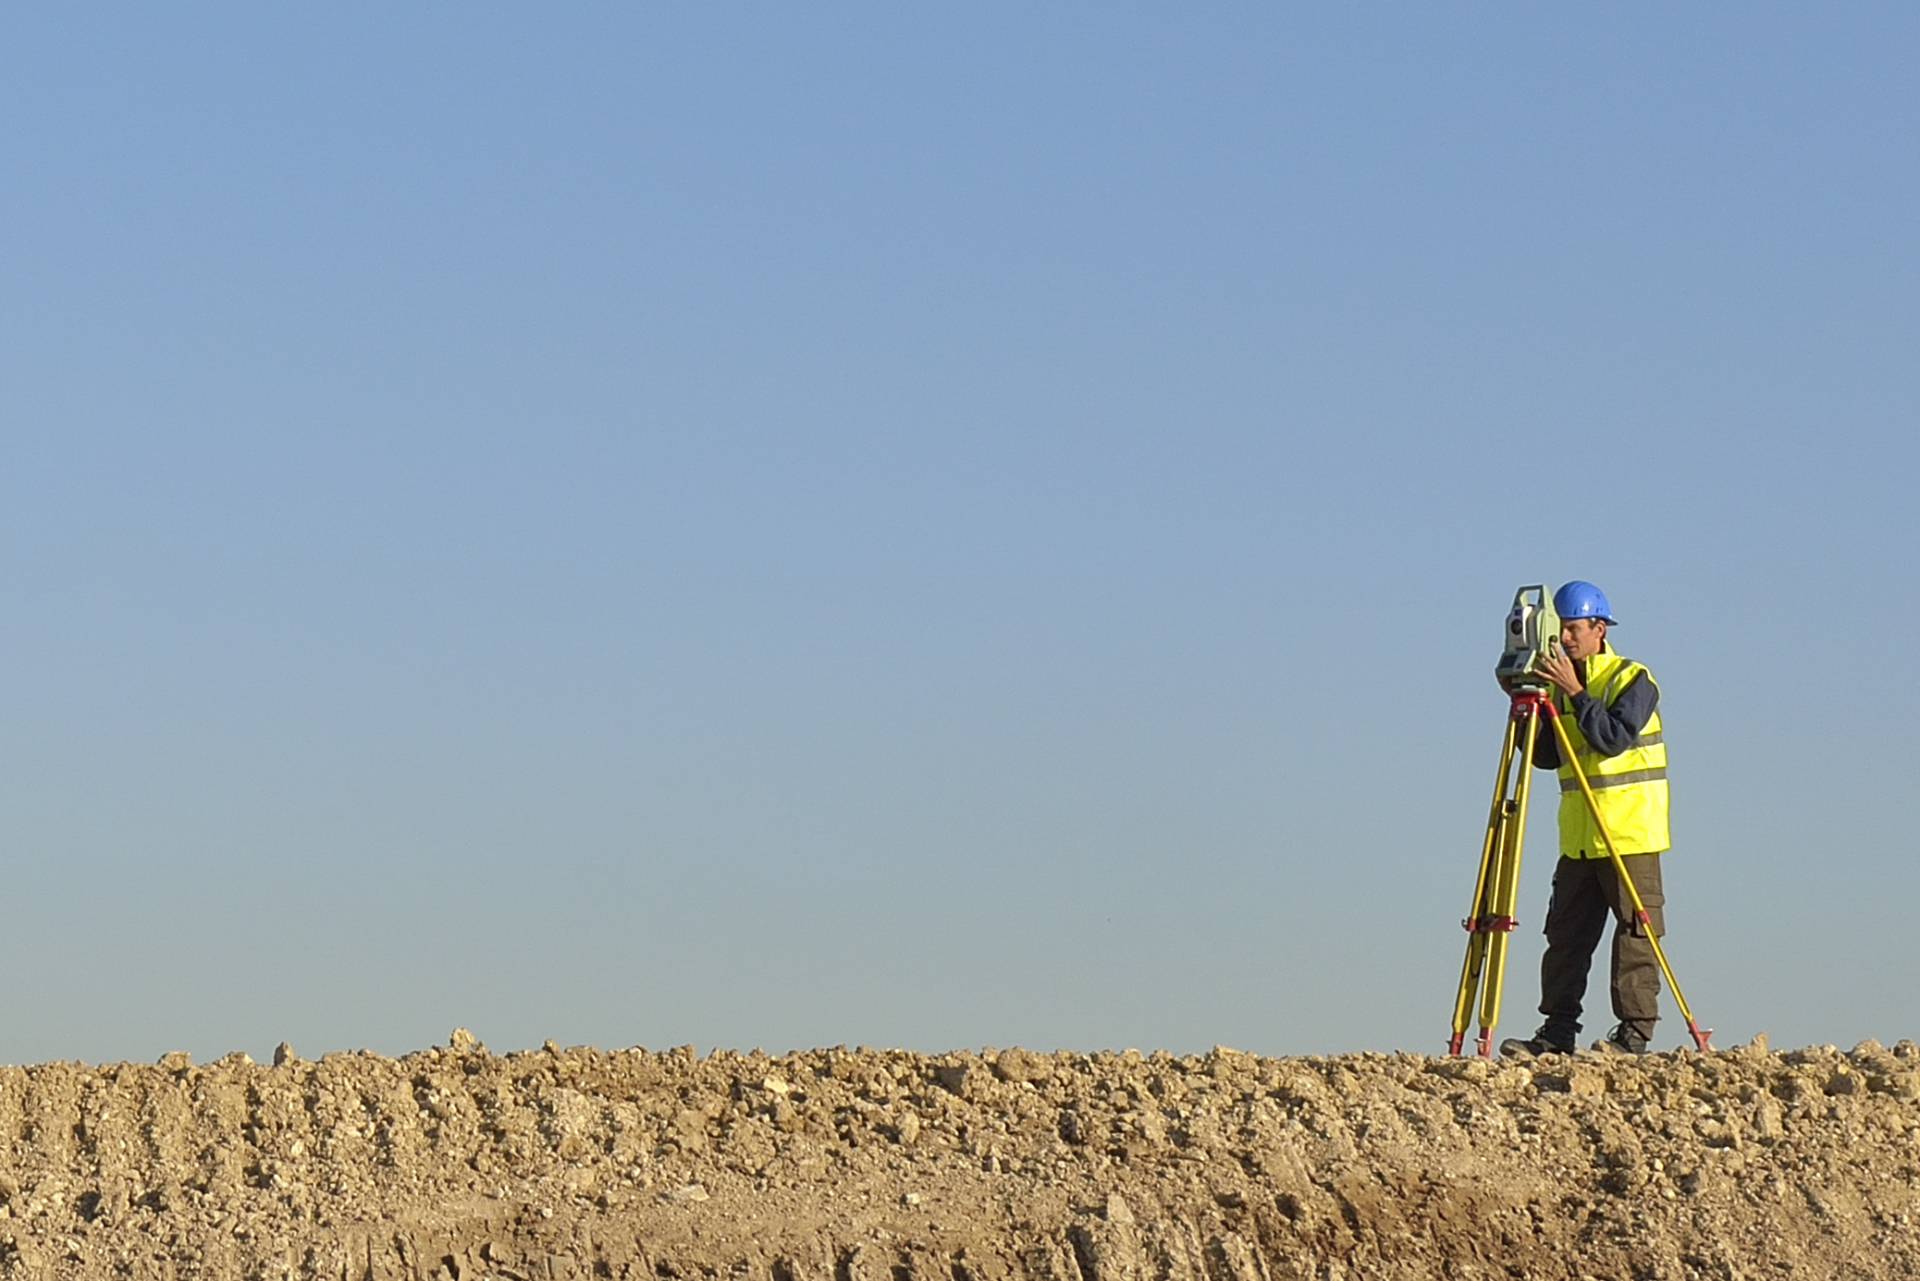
1500;580;1668;1054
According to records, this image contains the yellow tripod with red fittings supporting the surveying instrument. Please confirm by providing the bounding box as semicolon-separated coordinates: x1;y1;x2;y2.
1448;686;1713;1058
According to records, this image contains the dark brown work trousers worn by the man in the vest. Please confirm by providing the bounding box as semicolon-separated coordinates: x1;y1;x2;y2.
1540;855;1667;1039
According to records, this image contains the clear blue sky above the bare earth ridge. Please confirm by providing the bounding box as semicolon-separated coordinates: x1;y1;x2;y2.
0;4;1920;1062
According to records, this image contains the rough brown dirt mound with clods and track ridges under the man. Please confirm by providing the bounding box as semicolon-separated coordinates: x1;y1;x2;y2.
0;1033;1920;1281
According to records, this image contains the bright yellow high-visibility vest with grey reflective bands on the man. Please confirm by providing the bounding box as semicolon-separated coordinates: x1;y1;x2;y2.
1553;645;1672;858
